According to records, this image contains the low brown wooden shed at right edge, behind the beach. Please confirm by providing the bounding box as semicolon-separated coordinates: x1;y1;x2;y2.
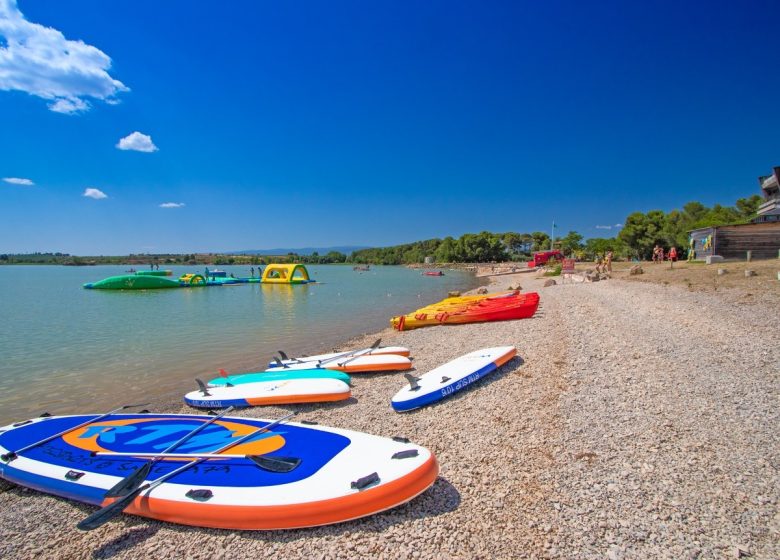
689;221;780;259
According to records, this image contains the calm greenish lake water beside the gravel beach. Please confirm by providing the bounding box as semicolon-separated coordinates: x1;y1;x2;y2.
0;266;477;425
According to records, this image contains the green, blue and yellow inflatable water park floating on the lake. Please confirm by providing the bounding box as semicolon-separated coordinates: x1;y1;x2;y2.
84;264;314;290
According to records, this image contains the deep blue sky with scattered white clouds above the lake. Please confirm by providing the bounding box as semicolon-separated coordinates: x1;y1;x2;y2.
0;0;780;255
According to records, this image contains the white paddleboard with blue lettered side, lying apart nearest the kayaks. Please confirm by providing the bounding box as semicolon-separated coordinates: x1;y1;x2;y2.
391;346;517;412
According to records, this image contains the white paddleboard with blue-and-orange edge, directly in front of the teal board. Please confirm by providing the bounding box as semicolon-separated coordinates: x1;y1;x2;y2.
184;377;352;408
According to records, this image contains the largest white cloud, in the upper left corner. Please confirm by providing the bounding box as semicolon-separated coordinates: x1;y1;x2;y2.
0;0;130;114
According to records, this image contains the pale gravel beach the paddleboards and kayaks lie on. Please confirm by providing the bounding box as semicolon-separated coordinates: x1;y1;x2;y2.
0;274;780;559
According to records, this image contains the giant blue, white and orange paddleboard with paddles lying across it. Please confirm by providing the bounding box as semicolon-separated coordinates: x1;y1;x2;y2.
0;414;439;530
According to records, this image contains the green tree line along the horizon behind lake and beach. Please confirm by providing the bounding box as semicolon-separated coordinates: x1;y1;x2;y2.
0;195;762;265
